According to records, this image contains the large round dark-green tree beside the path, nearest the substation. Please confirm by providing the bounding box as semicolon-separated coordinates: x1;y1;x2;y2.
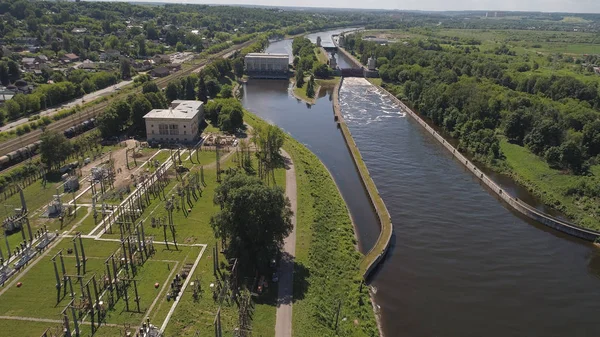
210;173;293;271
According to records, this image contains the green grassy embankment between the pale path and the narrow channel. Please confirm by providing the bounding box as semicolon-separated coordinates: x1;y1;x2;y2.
244;112;379;337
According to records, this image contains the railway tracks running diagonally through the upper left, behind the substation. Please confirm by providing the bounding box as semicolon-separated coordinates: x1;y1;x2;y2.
0;40;255;156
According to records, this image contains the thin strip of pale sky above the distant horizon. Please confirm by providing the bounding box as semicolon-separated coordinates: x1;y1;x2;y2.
120;0;600;13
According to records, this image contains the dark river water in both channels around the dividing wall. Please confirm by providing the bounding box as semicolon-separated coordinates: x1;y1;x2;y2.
243;33;600;337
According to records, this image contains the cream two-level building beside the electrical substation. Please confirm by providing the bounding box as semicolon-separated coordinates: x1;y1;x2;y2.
144;100;204;143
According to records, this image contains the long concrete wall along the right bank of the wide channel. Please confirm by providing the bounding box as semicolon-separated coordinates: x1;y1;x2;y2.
378;86;600;241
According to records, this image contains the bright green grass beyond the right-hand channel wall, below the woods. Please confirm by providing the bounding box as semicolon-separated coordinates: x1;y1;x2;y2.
500;139;600;230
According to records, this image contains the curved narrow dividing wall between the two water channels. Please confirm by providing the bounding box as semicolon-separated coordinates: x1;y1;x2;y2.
332;77;393;279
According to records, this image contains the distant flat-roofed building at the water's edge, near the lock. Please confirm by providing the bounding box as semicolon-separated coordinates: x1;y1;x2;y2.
244;53;290;78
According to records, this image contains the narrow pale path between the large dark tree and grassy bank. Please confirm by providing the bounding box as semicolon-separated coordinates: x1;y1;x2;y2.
275;150;298;337
